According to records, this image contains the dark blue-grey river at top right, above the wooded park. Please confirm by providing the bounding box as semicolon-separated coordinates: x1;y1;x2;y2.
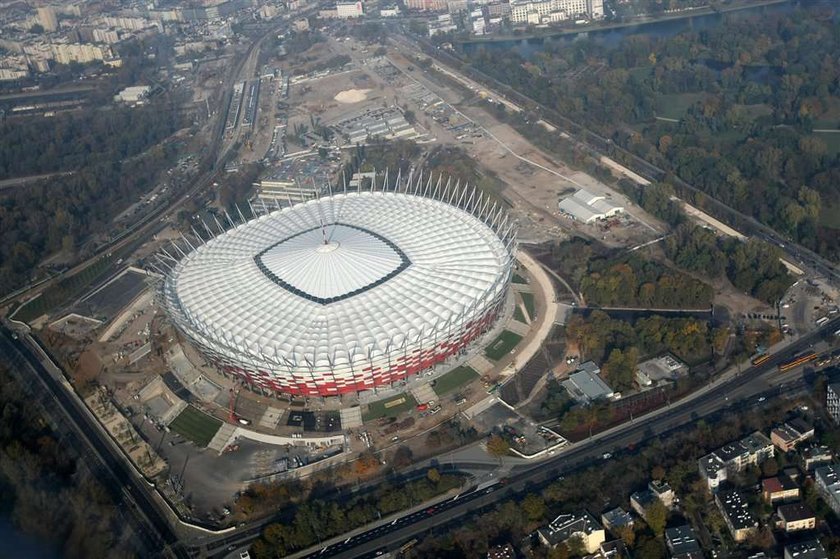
458;0;838;58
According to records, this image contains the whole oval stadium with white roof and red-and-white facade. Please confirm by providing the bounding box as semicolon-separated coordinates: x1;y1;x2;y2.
161;177;516;396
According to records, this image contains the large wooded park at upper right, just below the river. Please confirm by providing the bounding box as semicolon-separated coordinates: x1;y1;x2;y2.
469;8;840;259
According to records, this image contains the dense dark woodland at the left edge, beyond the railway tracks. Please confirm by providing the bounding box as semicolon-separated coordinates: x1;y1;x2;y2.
0;107;185;298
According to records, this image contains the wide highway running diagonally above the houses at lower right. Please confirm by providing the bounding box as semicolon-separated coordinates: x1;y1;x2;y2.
290;318;840;559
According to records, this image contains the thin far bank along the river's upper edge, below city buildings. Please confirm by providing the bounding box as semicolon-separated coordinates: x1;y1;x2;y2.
454;0;793;47
